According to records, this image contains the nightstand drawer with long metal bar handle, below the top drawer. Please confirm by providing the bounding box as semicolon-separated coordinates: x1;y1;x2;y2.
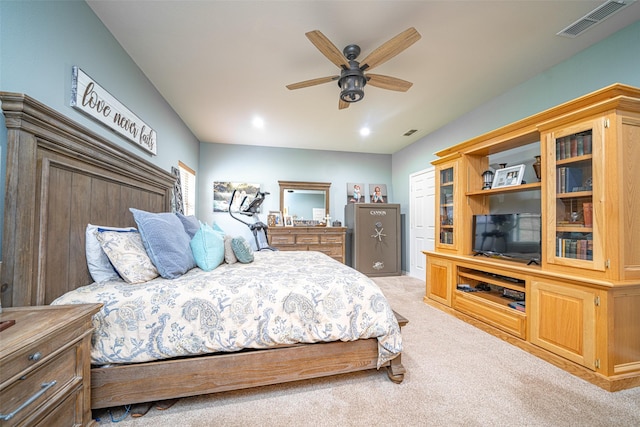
0;346;82;426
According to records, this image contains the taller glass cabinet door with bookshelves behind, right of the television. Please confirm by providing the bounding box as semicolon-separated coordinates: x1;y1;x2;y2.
547;120;604;269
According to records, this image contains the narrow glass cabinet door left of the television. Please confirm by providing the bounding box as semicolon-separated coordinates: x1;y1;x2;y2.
436;164;456;249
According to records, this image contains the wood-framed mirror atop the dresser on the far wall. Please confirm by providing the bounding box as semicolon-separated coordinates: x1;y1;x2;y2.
278;181;331;222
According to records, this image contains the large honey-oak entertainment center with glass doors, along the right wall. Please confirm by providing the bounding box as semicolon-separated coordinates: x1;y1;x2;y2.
424;84;640;391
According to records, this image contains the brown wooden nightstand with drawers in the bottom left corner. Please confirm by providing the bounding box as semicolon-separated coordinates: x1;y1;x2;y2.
0;304;101;426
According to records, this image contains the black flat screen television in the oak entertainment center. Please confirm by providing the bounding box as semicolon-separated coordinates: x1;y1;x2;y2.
473;213;542;264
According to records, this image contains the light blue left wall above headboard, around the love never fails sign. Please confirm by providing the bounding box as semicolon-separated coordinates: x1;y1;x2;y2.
0;0;199;256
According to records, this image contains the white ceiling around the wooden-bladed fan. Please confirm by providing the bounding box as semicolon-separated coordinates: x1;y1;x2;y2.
87;0;640;154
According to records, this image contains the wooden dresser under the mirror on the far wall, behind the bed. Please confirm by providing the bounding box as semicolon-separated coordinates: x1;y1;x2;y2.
269;227;347;264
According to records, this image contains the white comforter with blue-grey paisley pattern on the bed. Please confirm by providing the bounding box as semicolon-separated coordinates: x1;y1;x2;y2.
52;251;402;367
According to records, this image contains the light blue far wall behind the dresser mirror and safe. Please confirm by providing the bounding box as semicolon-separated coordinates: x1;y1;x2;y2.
196;143;393;241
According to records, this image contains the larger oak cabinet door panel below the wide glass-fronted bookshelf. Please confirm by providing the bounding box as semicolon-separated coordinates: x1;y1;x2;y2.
530;281;596;370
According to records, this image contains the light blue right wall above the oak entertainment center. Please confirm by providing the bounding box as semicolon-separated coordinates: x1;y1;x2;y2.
392;22;640;271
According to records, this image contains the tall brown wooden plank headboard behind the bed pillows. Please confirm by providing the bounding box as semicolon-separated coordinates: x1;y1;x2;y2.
0;92;175;307
